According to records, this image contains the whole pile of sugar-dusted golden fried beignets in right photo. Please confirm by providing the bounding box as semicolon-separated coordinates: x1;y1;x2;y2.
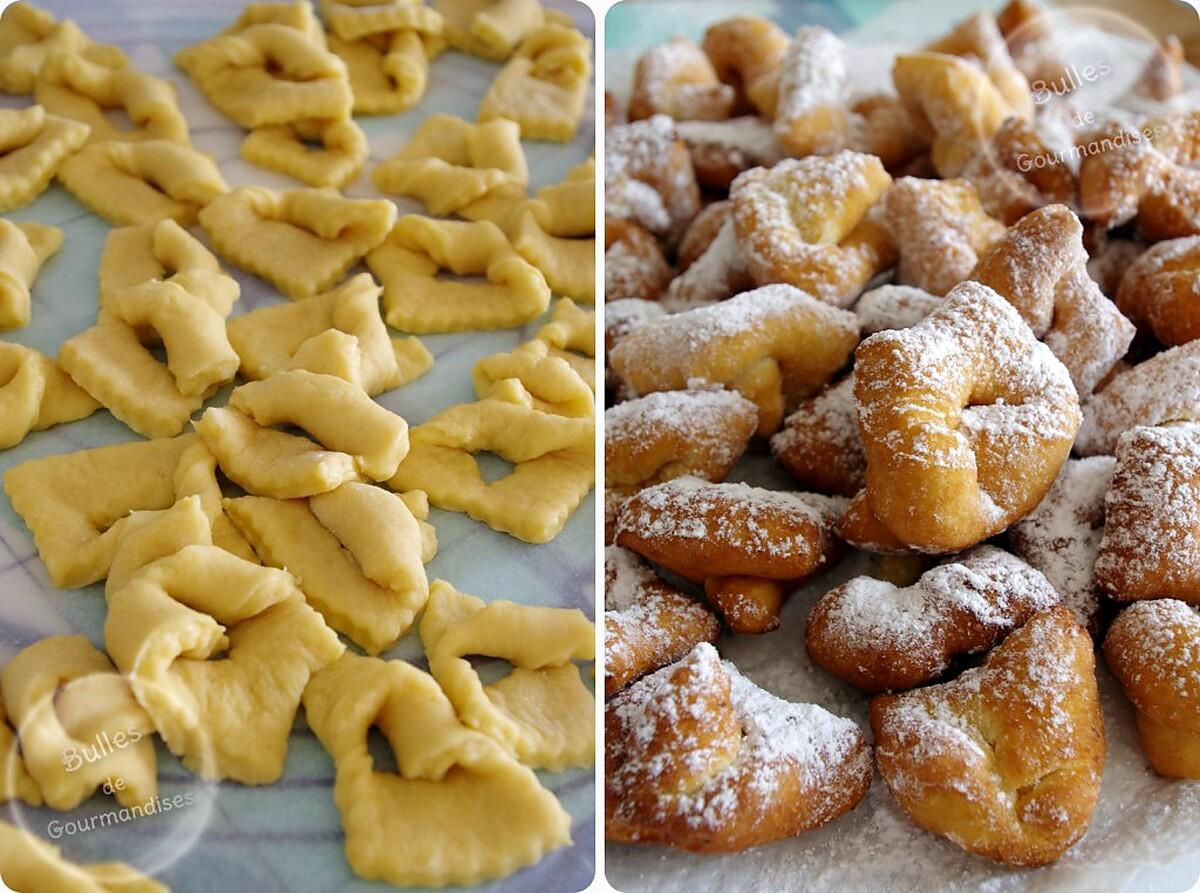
605;0;1200;865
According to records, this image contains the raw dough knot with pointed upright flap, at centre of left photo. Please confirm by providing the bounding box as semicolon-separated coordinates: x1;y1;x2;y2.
228;272;433;396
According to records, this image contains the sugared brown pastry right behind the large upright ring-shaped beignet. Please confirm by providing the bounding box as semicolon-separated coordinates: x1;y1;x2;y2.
971;204;1135;397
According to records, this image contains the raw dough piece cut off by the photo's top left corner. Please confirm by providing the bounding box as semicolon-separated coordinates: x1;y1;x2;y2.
0;2;128;94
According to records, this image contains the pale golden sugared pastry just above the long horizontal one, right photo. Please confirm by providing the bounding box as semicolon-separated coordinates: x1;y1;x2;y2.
730;151;895;306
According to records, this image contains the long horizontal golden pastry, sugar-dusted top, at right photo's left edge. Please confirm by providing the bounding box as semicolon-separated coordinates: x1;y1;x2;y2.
610;286;858;436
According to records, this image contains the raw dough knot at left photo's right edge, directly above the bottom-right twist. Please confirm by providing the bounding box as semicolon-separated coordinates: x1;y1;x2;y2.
421;580;595;772
